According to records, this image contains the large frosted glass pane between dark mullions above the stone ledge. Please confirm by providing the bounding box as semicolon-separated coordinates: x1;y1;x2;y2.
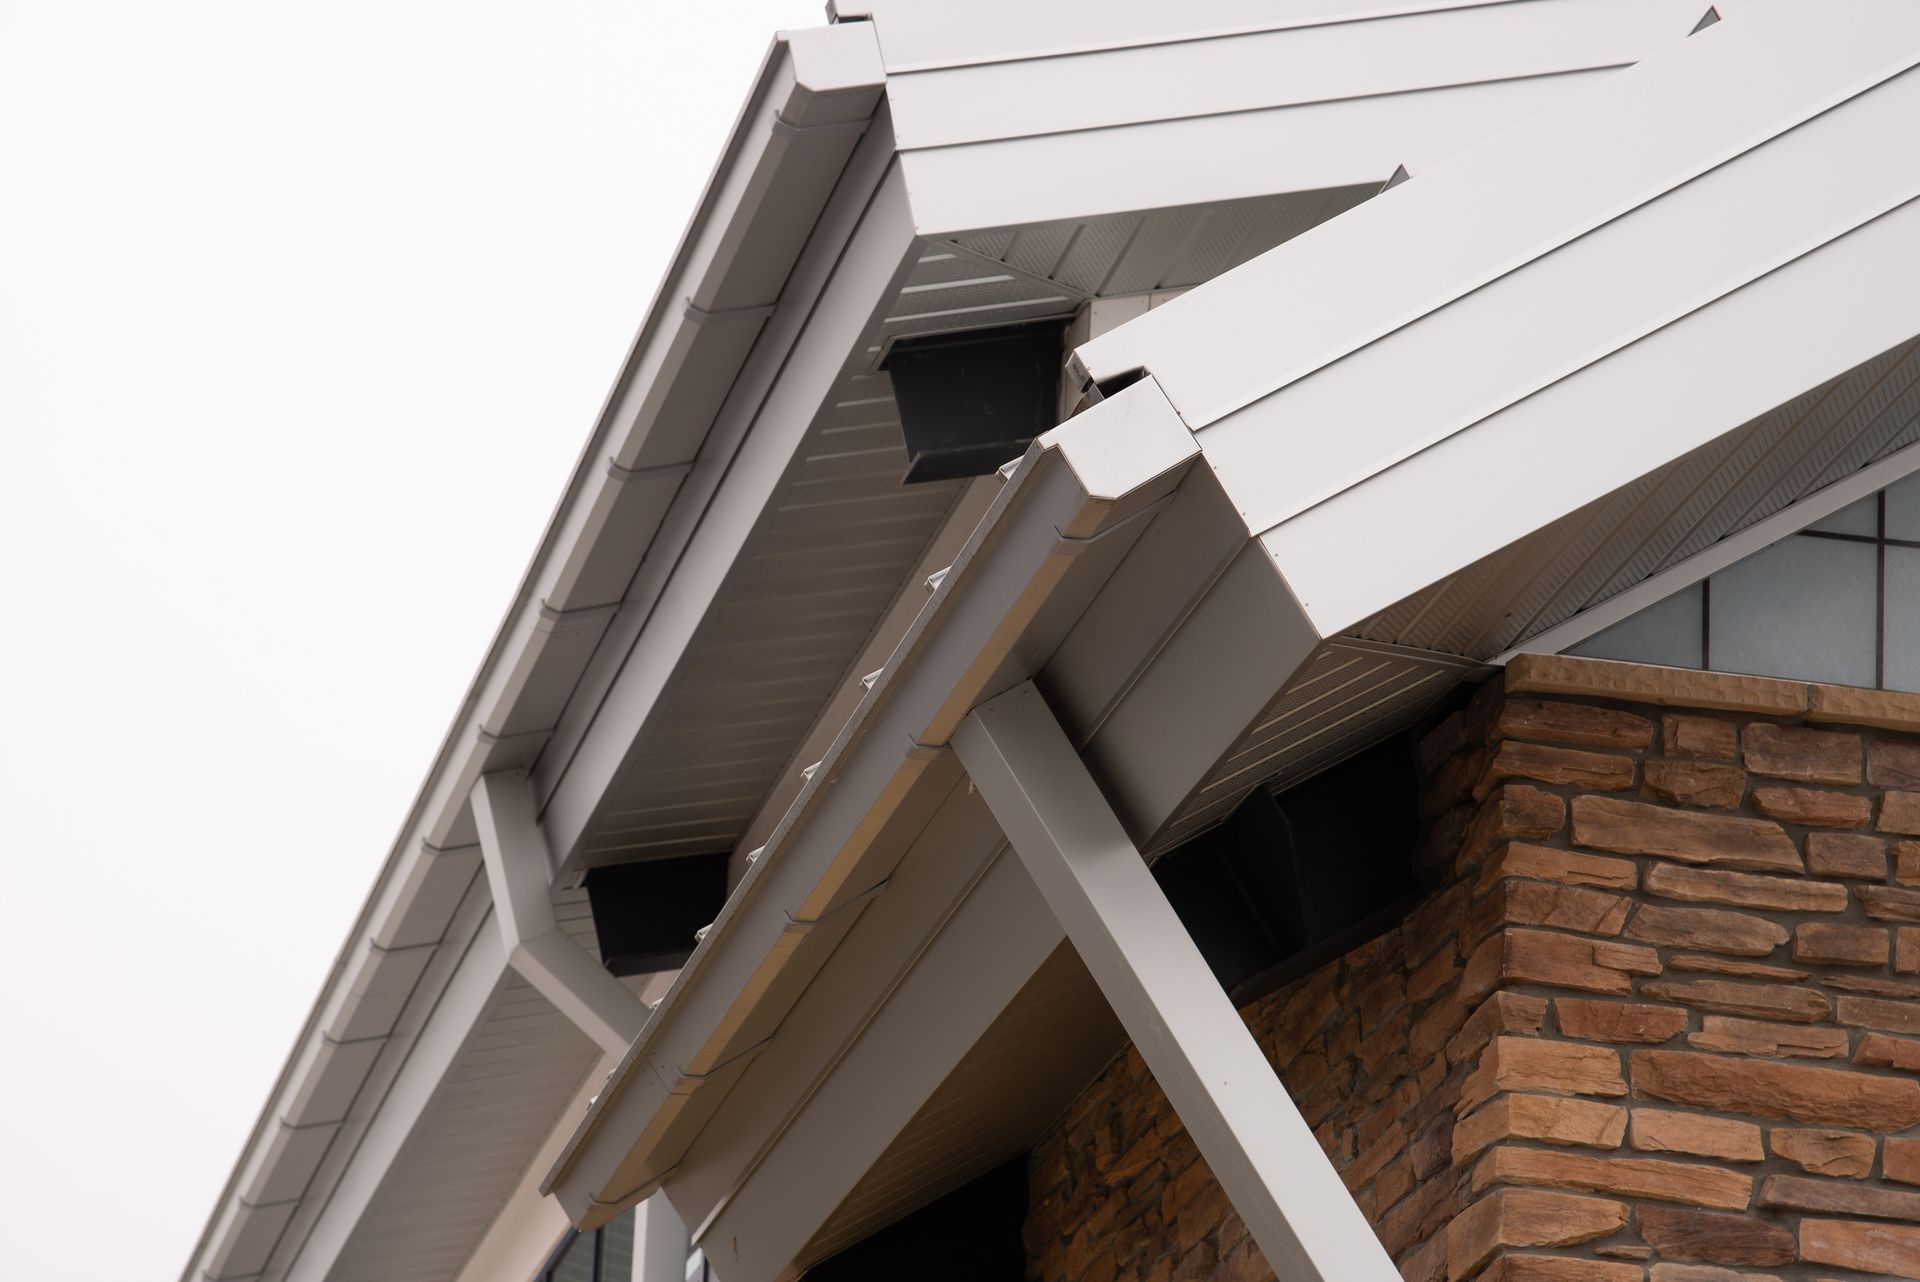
1707;535;1876;685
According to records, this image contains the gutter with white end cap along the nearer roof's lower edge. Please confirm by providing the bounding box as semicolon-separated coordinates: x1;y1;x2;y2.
547;380;1196;1226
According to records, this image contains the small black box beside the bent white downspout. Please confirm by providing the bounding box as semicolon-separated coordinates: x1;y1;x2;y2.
586;850;728;975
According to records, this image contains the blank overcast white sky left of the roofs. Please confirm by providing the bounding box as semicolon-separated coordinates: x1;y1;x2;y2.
0;0;824;1280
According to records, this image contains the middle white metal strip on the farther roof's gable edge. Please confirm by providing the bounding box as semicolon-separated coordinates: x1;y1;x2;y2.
881;0;1701;150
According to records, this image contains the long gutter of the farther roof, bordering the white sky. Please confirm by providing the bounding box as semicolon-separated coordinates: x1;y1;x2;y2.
182;23;885;1282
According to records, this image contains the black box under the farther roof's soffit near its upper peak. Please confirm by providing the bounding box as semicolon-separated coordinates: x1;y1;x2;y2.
883;321;1066;484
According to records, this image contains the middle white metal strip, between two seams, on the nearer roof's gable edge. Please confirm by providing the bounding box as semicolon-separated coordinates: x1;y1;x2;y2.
1205;59;1920;545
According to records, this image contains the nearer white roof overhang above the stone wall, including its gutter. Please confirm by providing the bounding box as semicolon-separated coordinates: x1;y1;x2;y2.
549;4;1920;1282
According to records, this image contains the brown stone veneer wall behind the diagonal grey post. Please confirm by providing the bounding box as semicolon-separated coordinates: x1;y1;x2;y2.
1027;658;1920;1282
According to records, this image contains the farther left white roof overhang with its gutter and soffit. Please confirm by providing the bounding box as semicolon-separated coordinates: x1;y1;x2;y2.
188;0;1758;1280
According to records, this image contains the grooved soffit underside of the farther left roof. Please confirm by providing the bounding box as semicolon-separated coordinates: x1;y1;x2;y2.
582;186;1377;867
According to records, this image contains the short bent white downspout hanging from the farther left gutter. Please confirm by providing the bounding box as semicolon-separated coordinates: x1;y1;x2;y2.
472;770;647;1056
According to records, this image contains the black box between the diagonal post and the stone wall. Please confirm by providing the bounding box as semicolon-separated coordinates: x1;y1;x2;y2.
1154;739;1421;1004
